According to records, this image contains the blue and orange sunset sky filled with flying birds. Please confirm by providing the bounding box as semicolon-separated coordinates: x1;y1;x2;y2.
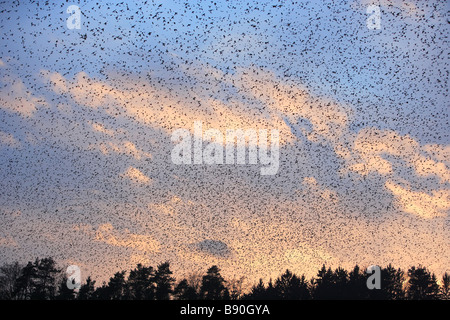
0;0;450;282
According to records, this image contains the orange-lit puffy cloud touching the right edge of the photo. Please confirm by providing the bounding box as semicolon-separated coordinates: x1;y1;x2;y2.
337;128;450;218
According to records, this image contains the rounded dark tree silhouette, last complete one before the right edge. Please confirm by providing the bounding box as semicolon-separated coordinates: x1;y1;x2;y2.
406;266;439;300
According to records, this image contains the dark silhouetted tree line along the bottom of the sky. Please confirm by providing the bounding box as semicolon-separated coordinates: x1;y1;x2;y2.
0;257;450;300
